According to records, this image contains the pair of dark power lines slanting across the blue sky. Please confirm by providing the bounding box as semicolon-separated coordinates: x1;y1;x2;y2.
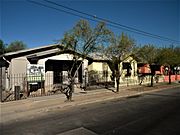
27;0;180;43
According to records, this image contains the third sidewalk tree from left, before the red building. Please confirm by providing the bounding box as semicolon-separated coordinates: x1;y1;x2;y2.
136;44;158;86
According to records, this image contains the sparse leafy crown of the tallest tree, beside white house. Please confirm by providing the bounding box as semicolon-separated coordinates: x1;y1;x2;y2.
61;20;111;56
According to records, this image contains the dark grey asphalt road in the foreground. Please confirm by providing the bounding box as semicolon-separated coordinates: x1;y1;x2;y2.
0;88;180;135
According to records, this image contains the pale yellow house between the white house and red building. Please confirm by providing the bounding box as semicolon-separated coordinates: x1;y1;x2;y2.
88;55;137;85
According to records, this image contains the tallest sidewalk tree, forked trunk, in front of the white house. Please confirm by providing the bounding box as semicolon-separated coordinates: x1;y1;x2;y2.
61;20;111;100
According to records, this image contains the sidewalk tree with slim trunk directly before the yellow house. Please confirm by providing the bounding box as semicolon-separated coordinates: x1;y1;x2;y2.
106;33;135;92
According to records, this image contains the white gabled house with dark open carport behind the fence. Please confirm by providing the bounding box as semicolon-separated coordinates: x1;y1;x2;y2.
0;44;90;99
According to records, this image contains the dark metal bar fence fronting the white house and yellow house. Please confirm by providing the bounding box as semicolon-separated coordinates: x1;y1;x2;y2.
0;72;114;102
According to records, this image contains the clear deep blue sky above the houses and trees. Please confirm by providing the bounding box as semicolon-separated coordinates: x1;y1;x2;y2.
0;0;180;48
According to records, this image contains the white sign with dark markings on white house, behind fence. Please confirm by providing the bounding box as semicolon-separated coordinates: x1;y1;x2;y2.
27;64;45;82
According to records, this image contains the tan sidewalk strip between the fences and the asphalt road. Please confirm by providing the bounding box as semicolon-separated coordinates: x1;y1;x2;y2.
0;84;180;123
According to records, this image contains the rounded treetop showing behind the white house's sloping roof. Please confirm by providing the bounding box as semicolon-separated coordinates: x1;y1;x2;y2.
5;40;27;53
